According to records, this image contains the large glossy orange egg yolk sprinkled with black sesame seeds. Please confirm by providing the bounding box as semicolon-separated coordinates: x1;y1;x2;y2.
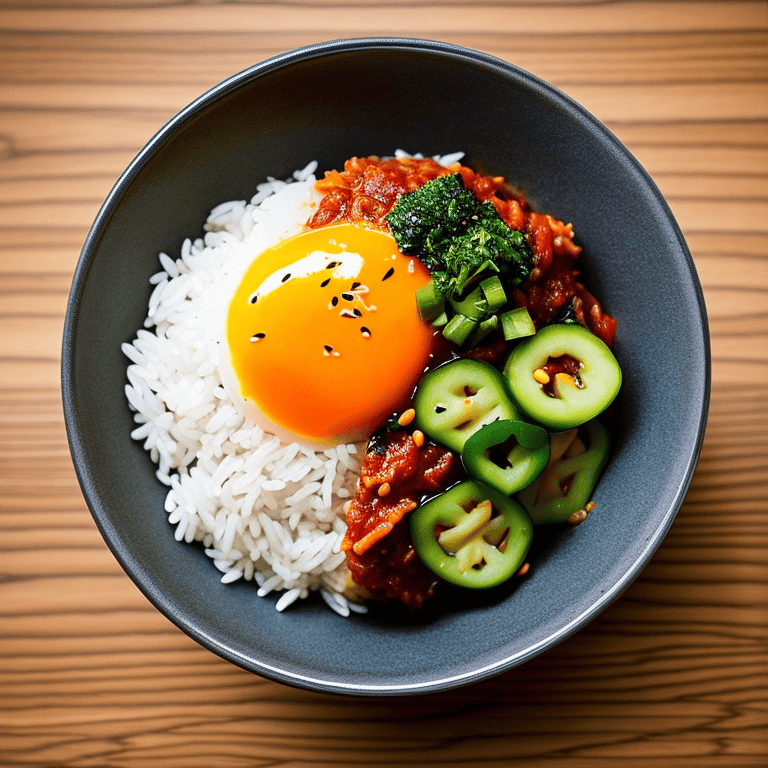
227;224;433;444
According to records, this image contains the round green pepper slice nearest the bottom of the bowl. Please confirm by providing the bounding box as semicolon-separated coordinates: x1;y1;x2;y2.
410;481;533;589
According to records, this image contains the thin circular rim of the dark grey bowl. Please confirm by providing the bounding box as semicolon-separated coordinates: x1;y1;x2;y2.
61;36;711;696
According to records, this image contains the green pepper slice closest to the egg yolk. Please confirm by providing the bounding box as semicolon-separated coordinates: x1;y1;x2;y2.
413;359;517;453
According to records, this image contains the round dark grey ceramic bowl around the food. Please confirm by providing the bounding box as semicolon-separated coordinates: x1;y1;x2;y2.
62;39;710;695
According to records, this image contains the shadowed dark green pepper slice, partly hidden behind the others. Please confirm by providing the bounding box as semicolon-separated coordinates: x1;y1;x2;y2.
517;419;610;525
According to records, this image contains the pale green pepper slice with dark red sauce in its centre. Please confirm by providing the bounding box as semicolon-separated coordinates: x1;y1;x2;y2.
504;325;621;430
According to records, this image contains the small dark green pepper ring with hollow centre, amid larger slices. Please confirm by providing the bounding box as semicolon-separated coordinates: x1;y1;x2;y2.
461;421;549;495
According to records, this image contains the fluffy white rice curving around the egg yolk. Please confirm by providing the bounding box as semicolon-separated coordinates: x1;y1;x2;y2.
122;151;461;616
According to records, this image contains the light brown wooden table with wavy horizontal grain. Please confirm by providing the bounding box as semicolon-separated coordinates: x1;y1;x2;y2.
0;0;768;768
